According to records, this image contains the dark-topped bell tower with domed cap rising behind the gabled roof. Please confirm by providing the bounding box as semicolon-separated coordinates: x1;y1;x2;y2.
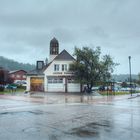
50;37;59;62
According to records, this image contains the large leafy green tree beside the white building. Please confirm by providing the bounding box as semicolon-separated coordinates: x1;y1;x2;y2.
70;47;117;92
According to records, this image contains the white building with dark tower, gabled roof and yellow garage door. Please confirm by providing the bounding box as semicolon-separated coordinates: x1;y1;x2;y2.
27;38;81;92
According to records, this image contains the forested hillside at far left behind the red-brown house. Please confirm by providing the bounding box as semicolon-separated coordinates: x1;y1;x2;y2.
0;56;35;71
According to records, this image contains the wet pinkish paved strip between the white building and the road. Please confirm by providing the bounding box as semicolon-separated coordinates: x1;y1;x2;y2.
0;92;140;104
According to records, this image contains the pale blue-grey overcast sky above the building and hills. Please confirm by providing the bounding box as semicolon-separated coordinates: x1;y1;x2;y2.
0;0;140;74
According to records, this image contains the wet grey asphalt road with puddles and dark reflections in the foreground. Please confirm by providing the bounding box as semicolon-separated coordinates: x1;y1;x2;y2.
0;97;140;140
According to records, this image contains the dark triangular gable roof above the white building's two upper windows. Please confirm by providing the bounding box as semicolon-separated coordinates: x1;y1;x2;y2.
54;50;75;60
